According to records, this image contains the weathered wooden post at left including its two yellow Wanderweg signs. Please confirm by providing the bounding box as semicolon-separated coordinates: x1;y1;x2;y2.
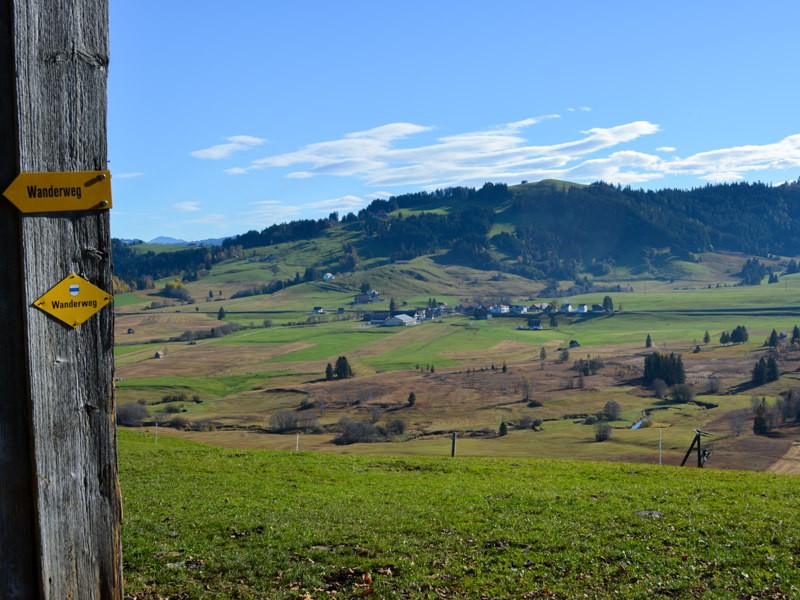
0;0;122;600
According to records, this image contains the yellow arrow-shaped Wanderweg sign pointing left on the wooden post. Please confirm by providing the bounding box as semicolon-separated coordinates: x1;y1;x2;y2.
3;171;111;213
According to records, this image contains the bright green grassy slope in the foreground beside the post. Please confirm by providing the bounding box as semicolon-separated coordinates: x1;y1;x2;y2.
119;431;800;600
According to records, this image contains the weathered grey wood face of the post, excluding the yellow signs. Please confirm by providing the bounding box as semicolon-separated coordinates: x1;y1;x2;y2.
0;0;122;600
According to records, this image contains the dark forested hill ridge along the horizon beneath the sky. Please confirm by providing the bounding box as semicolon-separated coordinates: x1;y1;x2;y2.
114;180;800;288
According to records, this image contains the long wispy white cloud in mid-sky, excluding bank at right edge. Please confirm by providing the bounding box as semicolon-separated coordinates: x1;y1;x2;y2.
227;114;659;187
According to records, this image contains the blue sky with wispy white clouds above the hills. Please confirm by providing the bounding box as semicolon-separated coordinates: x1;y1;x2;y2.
108;0;800;240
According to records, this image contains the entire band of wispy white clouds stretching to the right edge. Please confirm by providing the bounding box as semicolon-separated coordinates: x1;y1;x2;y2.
222;117;800;190
